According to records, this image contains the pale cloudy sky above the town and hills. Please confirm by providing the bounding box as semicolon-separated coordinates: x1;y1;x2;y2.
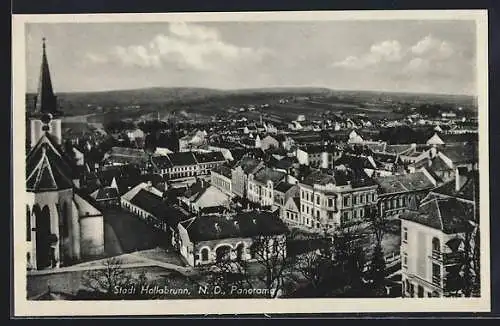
26;20;477;95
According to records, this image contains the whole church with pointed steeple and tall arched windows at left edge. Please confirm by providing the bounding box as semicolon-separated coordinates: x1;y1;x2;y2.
25;39;104;270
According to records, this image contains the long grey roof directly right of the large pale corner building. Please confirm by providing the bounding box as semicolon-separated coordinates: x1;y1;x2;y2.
375;172;434;194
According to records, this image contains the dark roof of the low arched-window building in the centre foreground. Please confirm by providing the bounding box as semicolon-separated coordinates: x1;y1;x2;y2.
181;211;288;242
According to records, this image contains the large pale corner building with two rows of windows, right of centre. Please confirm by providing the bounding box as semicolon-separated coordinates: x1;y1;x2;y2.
299;167;378;229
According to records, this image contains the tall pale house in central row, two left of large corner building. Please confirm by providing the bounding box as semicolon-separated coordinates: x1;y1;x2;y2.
247;167;286;206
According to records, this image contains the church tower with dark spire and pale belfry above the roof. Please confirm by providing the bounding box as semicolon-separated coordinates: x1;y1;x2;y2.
30;38;62;148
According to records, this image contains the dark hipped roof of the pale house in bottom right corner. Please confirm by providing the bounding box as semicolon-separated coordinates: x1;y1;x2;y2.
400;195;474;234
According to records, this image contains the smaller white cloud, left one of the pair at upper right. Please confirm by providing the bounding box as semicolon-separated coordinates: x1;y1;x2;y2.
333;40;404;69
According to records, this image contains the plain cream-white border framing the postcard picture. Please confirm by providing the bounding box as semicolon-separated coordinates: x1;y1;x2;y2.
12;10;491;317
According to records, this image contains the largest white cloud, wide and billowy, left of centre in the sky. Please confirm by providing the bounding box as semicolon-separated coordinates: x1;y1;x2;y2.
87;23;270;70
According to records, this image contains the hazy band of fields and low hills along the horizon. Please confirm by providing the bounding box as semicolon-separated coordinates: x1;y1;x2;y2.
26;88;474;124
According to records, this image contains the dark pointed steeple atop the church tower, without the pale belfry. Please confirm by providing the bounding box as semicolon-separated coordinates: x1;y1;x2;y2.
35;37;59;115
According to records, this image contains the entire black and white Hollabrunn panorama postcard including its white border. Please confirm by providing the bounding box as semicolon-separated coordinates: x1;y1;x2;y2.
12;10;490;316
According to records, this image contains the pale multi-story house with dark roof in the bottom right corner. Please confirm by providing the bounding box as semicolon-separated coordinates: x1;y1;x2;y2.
400;169;479;297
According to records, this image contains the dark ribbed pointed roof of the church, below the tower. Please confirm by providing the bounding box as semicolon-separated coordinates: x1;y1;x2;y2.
26;134;75;192
